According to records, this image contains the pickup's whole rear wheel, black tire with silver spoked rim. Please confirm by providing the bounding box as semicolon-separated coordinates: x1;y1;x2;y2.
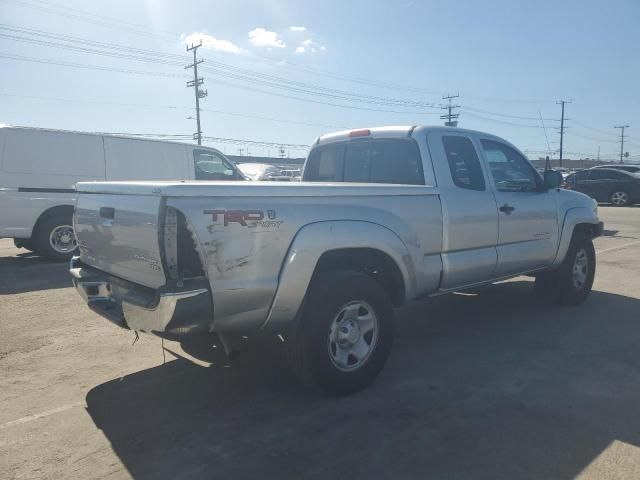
286;271;394;395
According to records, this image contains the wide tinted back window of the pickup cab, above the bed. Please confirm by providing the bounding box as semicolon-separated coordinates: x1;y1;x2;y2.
304;139;424;185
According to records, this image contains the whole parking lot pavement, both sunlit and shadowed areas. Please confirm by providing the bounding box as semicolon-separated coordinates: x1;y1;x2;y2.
0;207;640;479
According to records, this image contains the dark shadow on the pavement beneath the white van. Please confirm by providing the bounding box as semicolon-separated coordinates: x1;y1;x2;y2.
0;252;71;295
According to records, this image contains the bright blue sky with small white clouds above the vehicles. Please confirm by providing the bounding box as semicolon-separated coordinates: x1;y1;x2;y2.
0;0;640;161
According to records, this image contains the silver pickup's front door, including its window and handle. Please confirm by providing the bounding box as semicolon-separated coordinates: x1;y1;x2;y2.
480;139;558;277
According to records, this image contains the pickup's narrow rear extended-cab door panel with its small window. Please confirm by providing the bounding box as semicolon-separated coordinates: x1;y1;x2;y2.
427;132;498;290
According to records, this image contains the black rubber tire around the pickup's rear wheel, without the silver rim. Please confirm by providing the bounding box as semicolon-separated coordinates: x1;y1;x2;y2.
286;271;394;395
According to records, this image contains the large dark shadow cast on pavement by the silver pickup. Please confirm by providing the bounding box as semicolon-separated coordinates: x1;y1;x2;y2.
86;281;640;479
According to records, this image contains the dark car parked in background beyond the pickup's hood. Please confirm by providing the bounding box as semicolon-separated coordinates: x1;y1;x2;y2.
564;168;640;207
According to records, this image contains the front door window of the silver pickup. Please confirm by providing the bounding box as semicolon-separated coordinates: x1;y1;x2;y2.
481;140;538;192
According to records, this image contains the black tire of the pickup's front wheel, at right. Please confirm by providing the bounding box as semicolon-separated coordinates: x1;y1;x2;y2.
534;232;596;305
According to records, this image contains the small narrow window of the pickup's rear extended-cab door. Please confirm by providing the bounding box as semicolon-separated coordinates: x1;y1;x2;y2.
442;135;485;190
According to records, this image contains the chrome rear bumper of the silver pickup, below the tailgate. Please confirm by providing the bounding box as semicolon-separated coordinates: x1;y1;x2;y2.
69;257;213;338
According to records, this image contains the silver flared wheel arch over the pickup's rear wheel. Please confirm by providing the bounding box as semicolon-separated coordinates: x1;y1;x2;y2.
263;220;416;331
